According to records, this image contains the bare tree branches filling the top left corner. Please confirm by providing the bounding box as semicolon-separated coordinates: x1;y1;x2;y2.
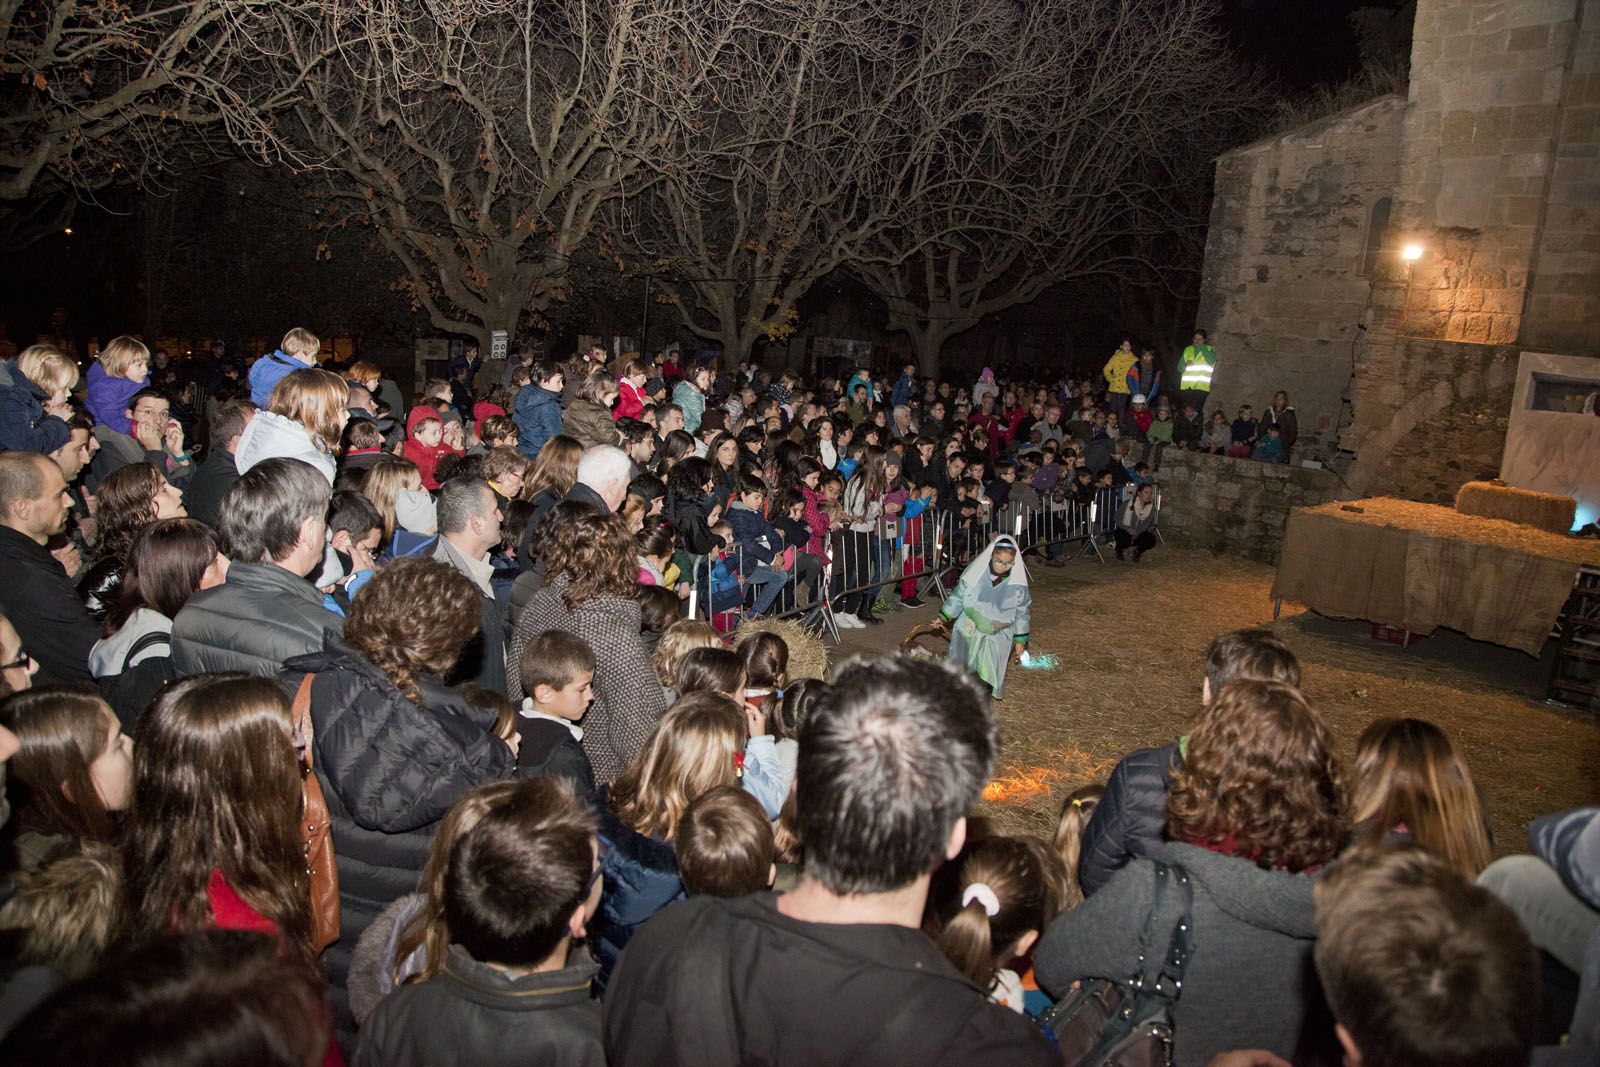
0;0;293;204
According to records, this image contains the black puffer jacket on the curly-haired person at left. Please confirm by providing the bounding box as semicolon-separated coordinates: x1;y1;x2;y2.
282;633;515;1030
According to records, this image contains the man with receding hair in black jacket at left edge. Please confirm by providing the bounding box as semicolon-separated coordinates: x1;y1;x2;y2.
0;453;99;683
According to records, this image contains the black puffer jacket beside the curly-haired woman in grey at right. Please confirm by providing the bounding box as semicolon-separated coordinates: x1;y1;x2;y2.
1078;741;1182;894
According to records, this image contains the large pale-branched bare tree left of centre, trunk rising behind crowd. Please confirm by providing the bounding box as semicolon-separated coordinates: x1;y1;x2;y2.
268;0;742;346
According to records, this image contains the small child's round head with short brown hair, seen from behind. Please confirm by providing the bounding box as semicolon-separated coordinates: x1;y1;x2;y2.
672;785;778;897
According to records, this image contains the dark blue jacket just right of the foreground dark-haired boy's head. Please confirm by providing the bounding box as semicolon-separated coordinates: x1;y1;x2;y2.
590;785;685;989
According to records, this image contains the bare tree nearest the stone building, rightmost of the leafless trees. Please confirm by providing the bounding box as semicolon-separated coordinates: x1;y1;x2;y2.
853;0;1254;374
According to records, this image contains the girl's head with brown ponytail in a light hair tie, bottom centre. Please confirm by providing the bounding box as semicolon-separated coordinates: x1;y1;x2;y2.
928;837;1066;1013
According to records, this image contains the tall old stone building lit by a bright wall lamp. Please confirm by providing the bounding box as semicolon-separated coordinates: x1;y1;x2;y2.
1200;0;1600;501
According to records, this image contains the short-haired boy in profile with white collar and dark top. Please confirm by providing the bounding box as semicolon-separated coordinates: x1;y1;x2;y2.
517;630;595;797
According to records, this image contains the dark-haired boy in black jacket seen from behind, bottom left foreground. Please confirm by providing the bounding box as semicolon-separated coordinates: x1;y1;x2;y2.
354;779;605;1067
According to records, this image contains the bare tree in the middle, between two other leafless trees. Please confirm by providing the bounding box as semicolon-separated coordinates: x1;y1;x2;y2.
624;0;984;358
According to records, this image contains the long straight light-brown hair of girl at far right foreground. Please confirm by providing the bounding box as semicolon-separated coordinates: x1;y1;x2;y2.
1352;718;1493;878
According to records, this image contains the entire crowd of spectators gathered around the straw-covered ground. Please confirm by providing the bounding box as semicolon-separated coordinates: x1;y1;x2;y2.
0;330;1600;1067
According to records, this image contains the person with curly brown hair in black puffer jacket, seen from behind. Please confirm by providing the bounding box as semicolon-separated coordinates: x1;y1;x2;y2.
282;557;517;1030
